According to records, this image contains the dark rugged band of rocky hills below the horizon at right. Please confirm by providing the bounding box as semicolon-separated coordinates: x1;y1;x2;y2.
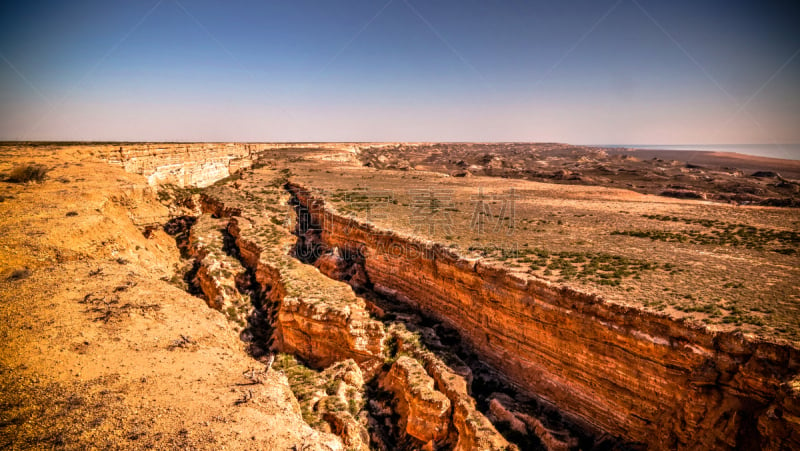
358;143;800;207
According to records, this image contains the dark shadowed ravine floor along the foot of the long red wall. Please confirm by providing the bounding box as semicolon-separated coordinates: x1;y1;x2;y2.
291;185;616;450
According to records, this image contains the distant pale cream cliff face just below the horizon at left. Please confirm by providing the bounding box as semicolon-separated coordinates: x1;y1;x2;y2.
93;143;266;187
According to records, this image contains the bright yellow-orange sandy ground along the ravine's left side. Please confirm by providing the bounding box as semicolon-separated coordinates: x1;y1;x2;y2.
0;149;339;449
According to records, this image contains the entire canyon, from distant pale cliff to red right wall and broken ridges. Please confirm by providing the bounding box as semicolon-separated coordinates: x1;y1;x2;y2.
1;144;800;450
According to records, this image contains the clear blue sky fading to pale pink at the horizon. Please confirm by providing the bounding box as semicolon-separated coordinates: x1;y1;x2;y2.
0;0;800;144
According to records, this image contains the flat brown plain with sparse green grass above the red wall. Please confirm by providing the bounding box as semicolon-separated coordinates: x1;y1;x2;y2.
198;151;800;342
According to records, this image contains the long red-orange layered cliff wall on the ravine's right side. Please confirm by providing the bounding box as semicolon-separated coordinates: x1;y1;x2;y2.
292;186;800;449
